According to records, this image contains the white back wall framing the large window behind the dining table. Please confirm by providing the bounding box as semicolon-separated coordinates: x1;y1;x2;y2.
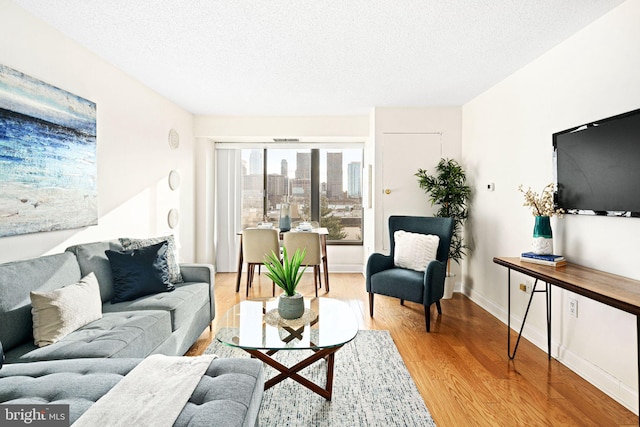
194;116;369;272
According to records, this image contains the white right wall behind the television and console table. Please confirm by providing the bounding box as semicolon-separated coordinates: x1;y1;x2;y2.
462;0;640;411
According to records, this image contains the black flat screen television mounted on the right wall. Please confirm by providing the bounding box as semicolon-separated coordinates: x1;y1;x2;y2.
553;109;640;217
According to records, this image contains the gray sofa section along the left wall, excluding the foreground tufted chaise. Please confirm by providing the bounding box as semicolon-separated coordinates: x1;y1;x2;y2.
0;240;215;363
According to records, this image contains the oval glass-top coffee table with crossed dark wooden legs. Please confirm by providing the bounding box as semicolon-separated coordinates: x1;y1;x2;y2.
215;298;358;400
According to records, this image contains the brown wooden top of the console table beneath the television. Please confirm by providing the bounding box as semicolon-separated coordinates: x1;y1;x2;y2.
493;257;640;315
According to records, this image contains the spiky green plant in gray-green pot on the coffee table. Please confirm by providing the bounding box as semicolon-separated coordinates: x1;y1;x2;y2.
264;248;307;319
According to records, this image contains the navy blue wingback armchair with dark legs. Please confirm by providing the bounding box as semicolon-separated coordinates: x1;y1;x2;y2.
367;216;453;332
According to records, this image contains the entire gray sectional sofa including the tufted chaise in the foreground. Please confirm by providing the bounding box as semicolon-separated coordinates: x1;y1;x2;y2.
0;240;264;426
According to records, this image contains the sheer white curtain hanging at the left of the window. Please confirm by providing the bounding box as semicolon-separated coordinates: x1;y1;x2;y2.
215;148;242;272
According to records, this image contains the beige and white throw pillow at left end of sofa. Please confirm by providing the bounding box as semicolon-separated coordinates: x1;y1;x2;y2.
31;273;102;347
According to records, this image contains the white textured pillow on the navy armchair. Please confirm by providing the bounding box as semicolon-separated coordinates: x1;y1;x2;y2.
393;230;440;271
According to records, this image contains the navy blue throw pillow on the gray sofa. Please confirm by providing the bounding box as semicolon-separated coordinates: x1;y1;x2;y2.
105;242;175;304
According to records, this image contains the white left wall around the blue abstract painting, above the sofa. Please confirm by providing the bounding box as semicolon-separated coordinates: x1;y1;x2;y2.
0;0;195;262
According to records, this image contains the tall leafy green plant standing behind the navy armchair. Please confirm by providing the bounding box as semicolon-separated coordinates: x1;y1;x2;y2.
415;159;471;298
